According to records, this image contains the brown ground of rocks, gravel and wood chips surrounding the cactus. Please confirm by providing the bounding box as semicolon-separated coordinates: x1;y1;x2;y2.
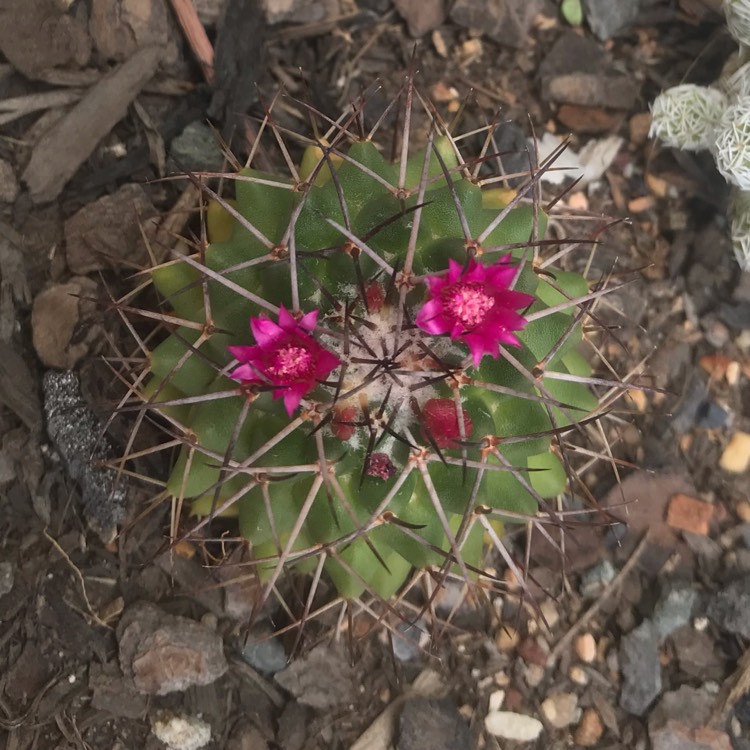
0;0;750;750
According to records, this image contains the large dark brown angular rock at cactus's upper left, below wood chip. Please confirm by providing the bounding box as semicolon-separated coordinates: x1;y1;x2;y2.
65;185;156;275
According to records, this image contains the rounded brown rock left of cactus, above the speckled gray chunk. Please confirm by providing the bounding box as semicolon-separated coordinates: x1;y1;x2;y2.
31;277;98;370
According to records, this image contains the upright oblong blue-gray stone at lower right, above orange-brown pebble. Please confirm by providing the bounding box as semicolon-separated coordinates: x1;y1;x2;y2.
620;620;661;716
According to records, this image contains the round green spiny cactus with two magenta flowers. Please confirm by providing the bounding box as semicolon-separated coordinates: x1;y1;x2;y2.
122;80;616;624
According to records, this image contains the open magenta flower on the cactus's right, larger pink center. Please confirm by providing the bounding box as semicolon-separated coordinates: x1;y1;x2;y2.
416;255;534;367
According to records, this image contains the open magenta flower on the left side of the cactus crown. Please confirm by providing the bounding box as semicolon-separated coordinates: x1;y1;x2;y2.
227;305;341;417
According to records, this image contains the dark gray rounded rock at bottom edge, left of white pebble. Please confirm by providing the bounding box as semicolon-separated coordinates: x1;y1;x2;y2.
396;698;474;750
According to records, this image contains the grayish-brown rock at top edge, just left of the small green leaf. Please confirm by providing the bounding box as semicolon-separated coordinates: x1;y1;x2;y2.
451;0;544;48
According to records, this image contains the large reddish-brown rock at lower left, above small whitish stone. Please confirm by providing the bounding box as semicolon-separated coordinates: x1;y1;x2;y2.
117;602;227;695
